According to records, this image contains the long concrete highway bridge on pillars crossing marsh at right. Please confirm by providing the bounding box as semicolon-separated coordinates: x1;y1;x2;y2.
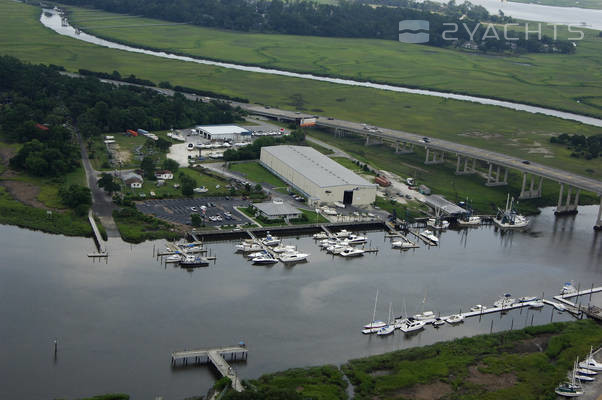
239;103;602;230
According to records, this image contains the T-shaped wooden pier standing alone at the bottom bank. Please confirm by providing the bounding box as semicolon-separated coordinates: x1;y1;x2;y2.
171;346;248;392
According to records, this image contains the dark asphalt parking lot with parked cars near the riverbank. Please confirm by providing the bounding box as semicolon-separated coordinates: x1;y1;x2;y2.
136;197;249;226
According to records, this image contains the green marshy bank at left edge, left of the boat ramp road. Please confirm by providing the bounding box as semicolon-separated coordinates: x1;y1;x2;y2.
0;186;92;236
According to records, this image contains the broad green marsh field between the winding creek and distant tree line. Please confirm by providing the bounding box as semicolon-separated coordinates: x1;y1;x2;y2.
68;5;602;116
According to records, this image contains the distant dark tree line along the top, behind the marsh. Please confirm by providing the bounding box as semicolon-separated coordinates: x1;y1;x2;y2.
59;0;575;53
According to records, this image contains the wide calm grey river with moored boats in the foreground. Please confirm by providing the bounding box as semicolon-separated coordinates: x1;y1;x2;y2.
0;207;602;399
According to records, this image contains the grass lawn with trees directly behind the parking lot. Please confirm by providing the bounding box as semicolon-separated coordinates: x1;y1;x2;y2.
126;168;230;199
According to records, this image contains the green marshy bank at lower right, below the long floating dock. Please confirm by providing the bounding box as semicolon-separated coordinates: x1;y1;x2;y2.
343;320;602;400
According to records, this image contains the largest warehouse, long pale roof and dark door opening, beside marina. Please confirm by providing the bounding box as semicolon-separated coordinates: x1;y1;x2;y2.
260;145;376;206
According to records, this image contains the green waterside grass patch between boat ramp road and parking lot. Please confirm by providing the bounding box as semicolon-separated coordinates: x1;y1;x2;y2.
113;207;182;243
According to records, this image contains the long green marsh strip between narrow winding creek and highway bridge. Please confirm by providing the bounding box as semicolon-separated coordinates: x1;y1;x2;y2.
0;0;602;179
